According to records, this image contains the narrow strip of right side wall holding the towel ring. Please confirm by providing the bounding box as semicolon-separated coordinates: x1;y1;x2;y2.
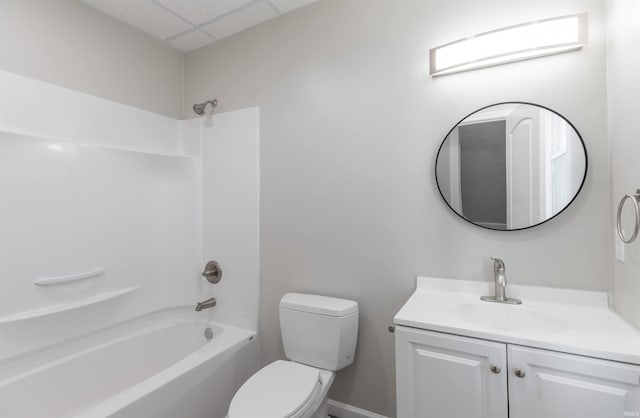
607;0;640;327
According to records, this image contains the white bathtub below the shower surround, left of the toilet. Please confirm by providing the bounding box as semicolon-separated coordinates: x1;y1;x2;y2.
0;308;258;418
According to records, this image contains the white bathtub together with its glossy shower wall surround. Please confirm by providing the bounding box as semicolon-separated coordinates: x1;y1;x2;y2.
0;72;259;418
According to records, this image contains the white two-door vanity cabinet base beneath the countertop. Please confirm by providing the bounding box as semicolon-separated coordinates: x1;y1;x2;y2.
395;326;640;418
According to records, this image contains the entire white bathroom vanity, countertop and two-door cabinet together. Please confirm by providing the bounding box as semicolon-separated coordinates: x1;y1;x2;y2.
394;277;640;418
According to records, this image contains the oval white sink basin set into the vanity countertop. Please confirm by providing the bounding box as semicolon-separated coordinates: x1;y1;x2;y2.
450;301;570;334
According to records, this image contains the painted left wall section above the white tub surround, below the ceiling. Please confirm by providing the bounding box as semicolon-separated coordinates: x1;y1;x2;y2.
0;0;183;118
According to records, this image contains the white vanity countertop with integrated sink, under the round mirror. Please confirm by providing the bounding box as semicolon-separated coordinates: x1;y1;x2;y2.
394;277;640;364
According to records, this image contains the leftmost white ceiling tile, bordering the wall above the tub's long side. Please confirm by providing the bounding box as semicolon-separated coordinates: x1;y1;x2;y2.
83;0;191;39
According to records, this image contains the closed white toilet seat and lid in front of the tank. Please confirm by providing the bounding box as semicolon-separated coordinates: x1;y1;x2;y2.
228;360;322;418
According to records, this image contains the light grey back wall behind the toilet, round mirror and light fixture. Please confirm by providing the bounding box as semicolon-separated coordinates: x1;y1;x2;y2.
184;0;612;416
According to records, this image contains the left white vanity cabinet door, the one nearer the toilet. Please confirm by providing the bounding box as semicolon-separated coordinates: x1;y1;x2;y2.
396;326;508;418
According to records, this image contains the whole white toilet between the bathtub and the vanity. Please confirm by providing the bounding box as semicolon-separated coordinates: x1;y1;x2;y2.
228;293;358;418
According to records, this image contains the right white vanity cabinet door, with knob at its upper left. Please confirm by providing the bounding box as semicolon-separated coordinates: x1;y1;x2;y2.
508;345;640;418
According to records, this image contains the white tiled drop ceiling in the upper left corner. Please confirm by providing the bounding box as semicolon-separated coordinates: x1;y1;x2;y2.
82;0;317;51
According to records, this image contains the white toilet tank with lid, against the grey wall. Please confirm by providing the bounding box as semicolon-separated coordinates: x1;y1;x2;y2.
280;293;358;371
